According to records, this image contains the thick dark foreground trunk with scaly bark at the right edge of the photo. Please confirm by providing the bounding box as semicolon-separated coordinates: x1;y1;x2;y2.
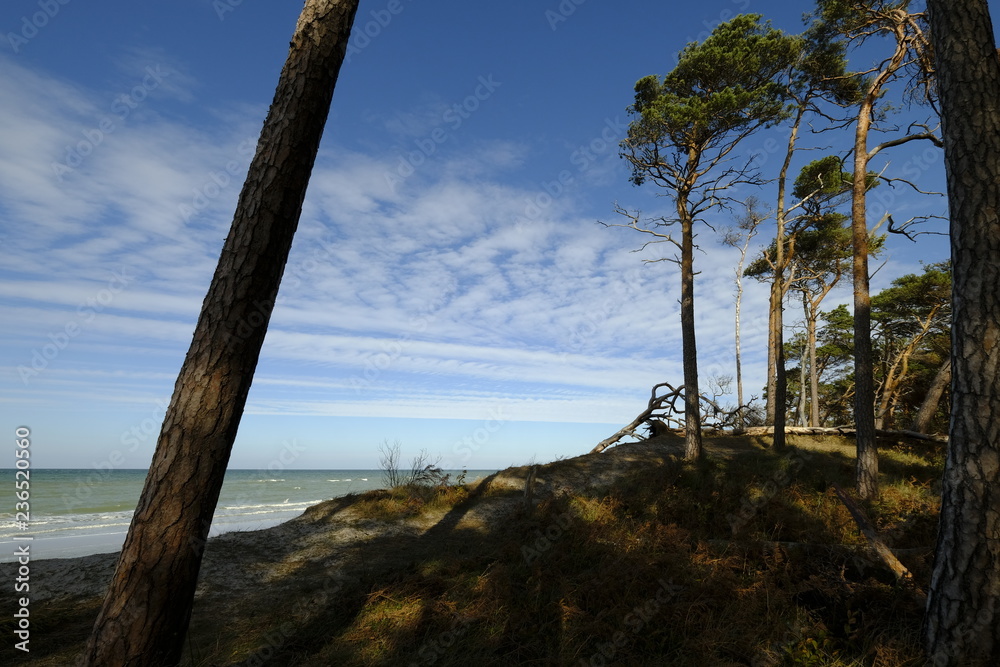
924;0;1000;667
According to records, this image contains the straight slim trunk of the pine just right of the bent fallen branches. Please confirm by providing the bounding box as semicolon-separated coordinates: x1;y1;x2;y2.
677;206;702;461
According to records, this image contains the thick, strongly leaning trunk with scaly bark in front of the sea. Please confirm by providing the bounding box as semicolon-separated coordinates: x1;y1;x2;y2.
83;0;358;667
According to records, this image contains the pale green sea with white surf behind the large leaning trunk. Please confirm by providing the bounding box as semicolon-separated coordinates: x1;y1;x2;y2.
0;468;495;563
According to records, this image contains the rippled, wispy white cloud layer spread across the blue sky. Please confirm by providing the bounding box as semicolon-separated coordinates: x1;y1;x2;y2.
0;54;766;423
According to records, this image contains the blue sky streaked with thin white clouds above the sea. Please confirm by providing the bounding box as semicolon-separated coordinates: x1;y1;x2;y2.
0;0;964;469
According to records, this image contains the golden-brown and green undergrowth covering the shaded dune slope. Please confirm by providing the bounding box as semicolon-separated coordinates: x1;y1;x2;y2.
9;436;940;667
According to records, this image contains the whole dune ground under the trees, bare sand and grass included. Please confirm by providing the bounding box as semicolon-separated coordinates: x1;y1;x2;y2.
0;436;943;667
